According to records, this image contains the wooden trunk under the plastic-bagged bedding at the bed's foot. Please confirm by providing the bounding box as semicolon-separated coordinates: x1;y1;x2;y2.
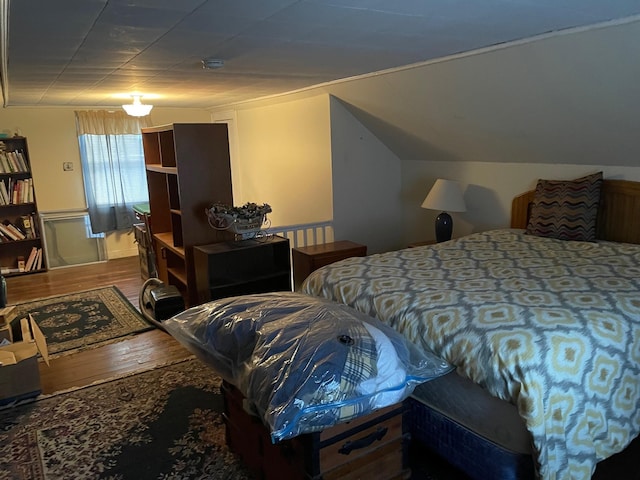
222;382;411;480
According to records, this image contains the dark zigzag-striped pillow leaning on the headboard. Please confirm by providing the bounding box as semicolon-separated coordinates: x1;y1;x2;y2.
526;172;602;242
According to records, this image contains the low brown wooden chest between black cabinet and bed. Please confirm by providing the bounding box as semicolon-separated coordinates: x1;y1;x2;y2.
291;240;367;290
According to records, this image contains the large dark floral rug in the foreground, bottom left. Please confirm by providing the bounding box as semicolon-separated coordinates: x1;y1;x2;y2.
0;359;251;480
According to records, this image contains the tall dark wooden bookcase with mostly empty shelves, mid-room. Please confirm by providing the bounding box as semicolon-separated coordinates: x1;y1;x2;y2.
142;123;233;306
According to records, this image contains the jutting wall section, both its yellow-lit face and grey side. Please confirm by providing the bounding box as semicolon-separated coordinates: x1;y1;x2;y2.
212;94;402;252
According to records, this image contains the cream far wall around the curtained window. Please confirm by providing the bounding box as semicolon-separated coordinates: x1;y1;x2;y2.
0;107;211;258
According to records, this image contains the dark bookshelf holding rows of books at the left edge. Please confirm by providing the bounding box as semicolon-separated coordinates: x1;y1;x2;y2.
0;137;47;277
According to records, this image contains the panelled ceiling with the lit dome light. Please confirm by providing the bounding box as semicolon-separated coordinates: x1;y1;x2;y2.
0;0;640;108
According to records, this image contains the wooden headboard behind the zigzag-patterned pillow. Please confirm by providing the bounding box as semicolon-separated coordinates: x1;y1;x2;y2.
511;180;640;244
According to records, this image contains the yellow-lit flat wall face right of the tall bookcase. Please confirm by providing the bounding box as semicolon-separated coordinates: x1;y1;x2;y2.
225;95;333;226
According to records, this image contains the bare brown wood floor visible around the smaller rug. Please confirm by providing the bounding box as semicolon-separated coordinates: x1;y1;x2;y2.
7;257;190;394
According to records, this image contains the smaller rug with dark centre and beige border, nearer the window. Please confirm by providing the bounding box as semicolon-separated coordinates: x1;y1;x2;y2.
12;286;155;358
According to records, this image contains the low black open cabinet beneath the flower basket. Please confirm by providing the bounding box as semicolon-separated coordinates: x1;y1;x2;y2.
194;236;291;303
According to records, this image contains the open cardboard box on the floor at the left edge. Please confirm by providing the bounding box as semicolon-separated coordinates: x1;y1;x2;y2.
0;315;49;405
